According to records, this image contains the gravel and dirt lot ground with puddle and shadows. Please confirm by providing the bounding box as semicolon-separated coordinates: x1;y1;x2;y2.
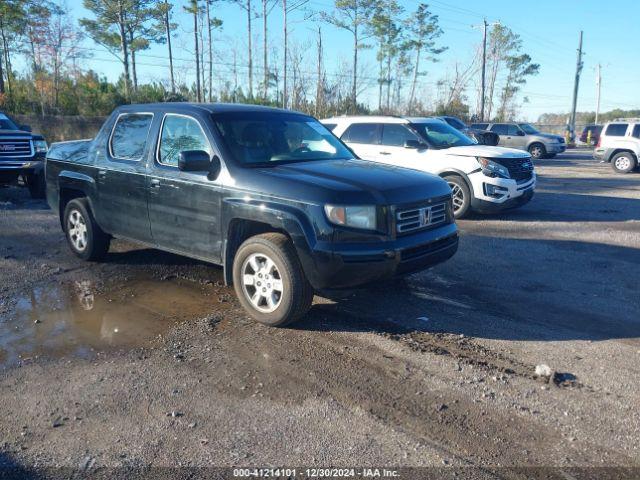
0;151;640;479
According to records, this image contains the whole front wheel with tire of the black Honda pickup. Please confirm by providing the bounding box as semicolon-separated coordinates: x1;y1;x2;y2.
233;233;314;327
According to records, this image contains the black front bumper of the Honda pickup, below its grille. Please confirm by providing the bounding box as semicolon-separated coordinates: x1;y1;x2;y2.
305;223;458;290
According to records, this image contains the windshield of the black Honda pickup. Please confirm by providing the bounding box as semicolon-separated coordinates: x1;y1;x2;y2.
213;112;354;167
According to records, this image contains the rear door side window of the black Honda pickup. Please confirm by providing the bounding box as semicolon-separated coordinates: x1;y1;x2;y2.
109;113;153;160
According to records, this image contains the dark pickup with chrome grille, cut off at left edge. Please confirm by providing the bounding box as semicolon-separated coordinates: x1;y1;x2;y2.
0;112;47;198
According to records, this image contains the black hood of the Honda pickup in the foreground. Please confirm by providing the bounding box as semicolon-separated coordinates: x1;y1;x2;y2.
248;159;451;205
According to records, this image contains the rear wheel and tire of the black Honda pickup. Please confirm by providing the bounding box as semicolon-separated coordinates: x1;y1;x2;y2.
63;198;111;261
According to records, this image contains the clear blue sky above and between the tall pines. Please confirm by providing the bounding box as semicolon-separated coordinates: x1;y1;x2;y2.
53;0;640;121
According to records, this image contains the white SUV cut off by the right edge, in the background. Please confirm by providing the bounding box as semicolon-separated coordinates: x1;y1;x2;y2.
593;119;640;173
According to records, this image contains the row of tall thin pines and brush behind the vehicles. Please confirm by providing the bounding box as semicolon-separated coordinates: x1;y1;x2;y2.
0;0;540;119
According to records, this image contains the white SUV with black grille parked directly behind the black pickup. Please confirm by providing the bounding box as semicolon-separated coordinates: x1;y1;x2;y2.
321;117;536;218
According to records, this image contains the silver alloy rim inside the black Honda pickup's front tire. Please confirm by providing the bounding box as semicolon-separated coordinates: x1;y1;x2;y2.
242;253;284;313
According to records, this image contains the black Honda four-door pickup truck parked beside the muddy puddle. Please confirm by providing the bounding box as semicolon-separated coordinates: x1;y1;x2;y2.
46;103;458;326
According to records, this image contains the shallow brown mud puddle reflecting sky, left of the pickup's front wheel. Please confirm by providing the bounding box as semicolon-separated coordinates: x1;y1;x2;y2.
0;278;213;367
